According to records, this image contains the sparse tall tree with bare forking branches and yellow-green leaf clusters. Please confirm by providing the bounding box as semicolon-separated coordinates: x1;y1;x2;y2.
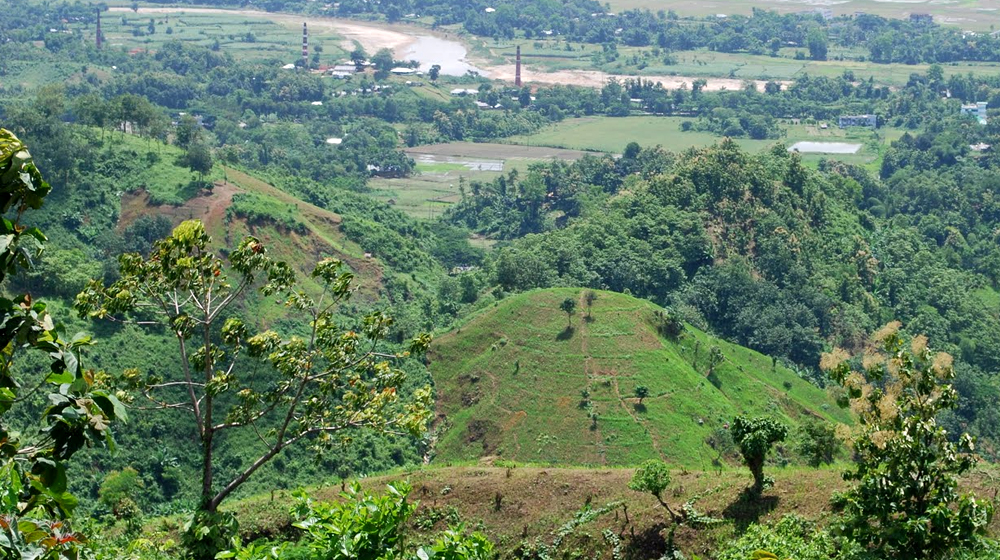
76;220;431;558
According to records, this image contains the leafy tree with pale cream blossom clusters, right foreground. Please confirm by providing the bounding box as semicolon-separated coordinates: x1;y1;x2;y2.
820;323;993;558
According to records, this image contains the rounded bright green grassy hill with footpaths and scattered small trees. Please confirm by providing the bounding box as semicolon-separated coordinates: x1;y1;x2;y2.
429;289;849;468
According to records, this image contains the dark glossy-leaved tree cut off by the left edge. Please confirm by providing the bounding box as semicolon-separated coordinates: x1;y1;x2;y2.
0;129;125;559
